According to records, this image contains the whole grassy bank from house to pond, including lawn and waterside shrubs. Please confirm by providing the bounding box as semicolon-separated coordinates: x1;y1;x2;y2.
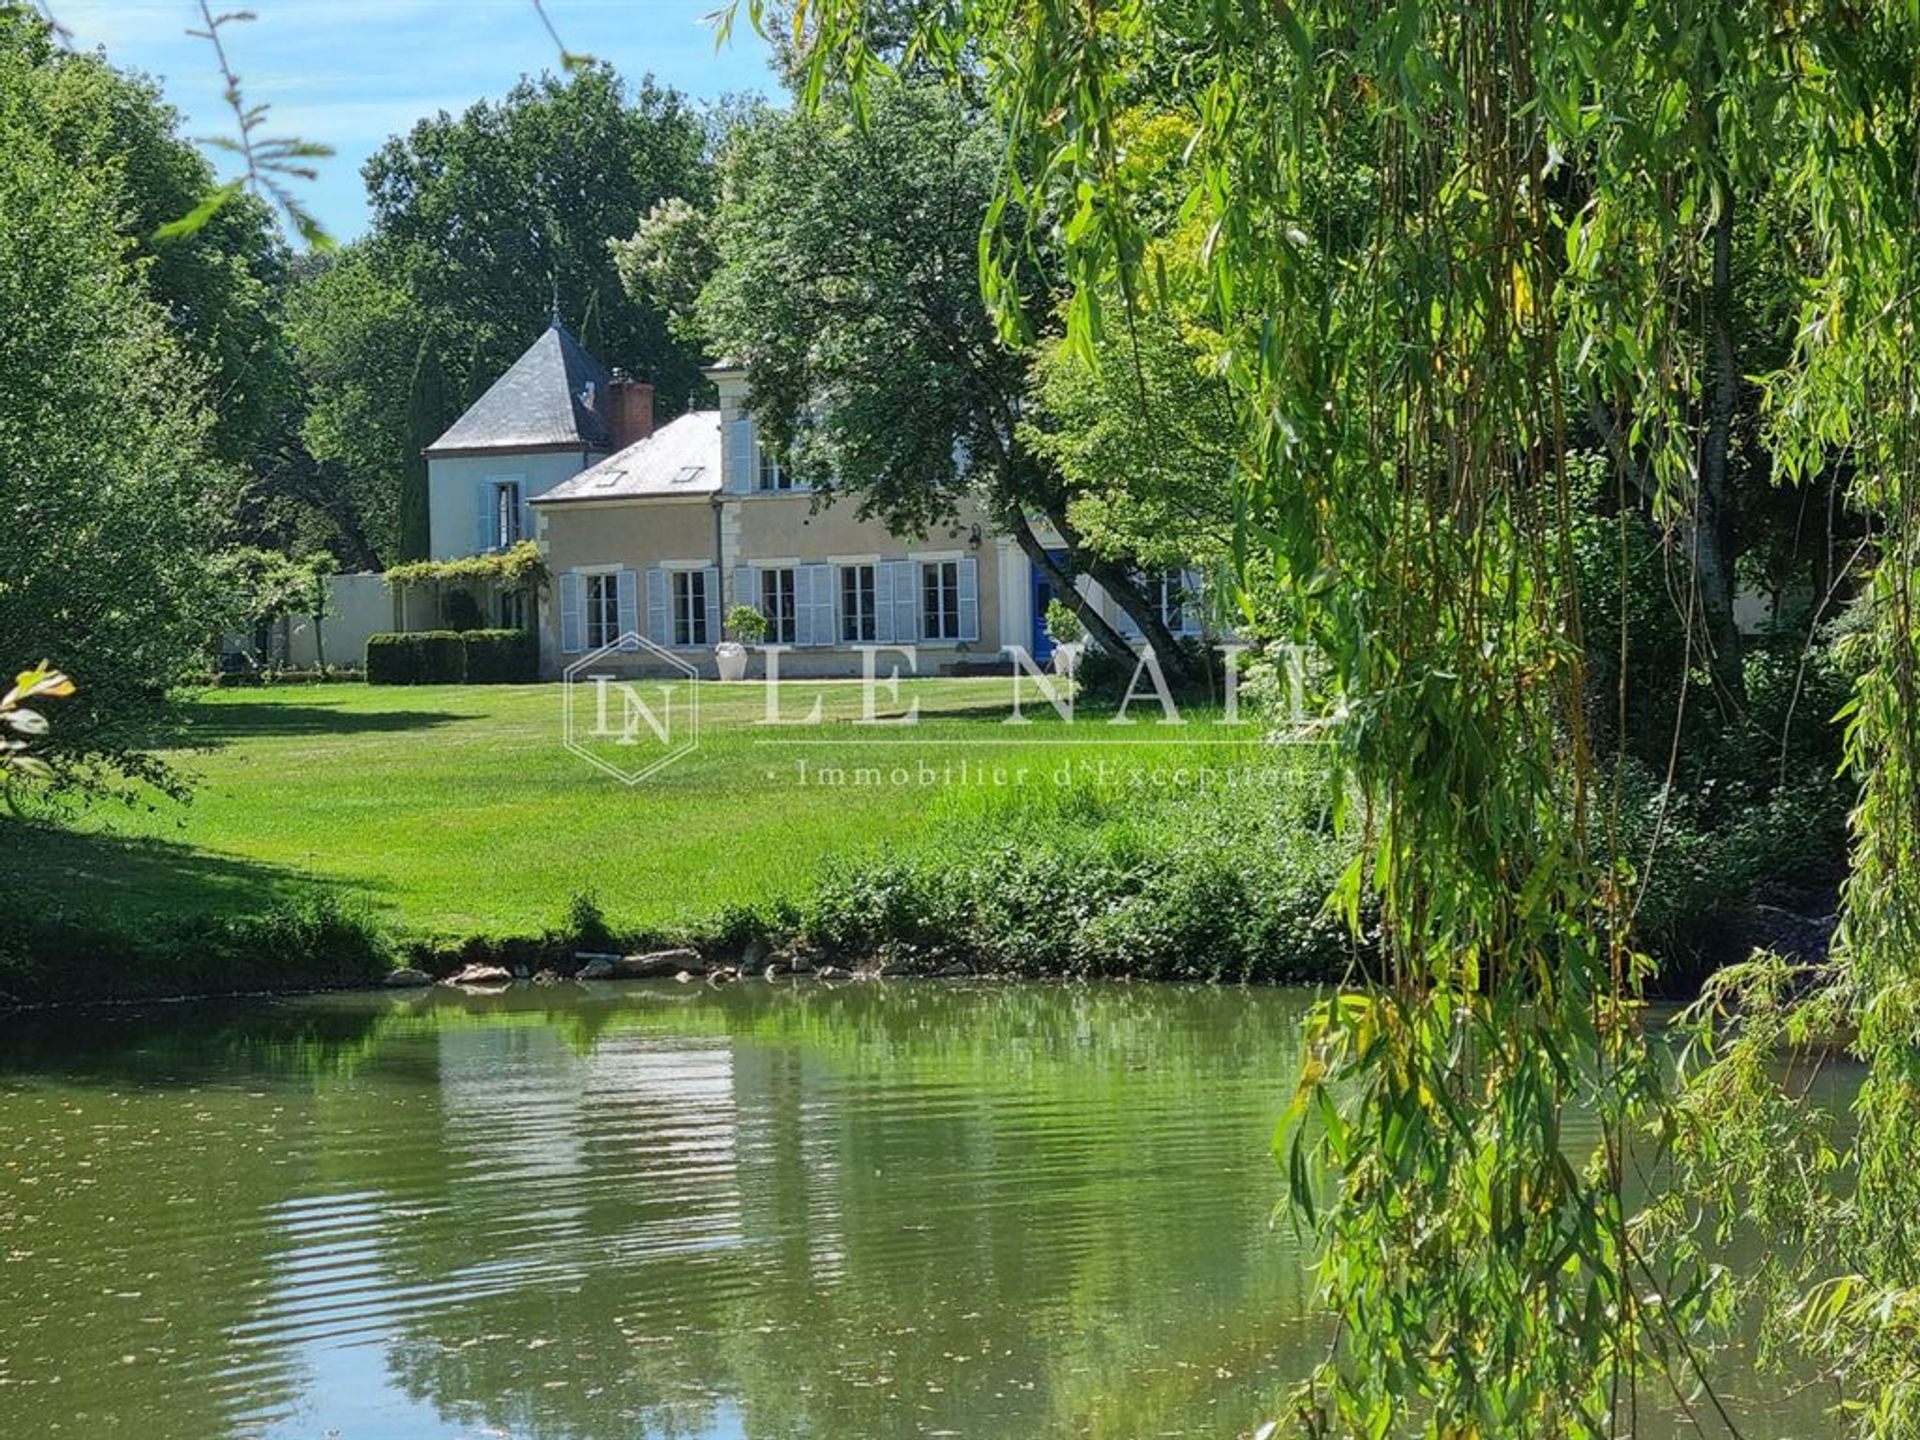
0;680;1342;998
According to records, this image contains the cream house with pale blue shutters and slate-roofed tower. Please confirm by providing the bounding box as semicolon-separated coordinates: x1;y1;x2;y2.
424;317;1198;676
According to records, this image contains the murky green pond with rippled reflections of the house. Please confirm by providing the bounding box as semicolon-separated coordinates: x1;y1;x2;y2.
0;983;1816;1440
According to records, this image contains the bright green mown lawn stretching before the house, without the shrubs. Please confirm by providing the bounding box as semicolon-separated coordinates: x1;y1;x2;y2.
18;680;1274;937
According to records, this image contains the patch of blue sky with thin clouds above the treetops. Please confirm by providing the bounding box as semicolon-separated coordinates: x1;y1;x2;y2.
50;0;780;240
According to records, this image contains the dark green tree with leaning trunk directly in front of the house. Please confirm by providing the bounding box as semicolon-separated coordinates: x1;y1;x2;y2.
683;81;1190;676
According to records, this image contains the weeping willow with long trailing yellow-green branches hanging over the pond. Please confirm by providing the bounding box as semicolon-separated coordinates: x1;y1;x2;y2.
760;0;1920;1436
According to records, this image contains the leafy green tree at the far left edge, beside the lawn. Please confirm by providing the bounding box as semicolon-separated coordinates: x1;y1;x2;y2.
0;10;234;781
